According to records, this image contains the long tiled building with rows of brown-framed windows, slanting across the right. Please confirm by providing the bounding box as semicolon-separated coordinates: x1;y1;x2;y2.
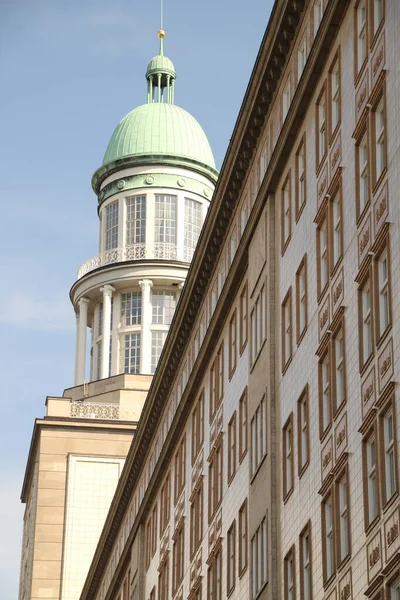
21;0;400;600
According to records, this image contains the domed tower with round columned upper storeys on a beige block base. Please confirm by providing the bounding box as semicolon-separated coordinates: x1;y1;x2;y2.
19;30;218;600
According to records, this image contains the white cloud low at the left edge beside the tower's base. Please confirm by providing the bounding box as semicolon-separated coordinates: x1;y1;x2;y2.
0;470;24;600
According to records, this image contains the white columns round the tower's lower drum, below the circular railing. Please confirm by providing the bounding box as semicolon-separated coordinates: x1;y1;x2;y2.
75;279;160;385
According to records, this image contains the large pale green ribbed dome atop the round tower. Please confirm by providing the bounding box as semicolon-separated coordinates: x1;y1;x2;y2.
103;102;215;169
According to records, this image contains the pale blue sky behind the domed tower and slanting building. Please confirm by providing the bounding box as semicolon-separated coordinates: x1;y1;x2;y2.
0;0;272;600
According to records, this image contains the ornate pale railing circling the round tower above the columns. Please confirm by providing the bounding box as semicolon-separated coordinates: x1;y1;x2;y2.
77;242;194;279
